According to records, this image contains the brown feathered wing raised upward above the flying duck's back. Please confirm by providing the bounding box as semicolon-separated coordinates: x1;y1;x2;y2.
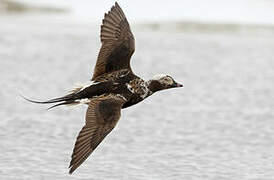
92;2;135;80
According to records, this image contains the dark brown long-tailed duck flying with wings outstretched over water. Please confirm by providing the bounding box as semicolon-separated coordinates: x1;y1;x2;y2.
24;2;183;174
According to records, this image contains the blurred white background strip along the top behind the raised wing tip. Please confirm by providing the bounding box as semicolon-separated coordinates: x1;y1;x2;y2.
1;0;274;24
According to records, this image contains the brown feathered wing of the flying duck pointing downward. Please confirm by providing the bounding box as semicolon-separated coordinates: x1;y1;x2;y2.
69;94;125;174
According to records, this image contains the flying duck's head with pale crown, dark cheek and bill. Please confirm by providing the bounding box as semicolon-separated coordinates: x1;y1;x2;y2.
149;74;183;92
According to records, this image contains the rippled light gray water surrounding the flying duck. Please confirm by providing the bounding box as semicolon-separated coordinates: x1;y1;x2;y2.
0;18;274;180
